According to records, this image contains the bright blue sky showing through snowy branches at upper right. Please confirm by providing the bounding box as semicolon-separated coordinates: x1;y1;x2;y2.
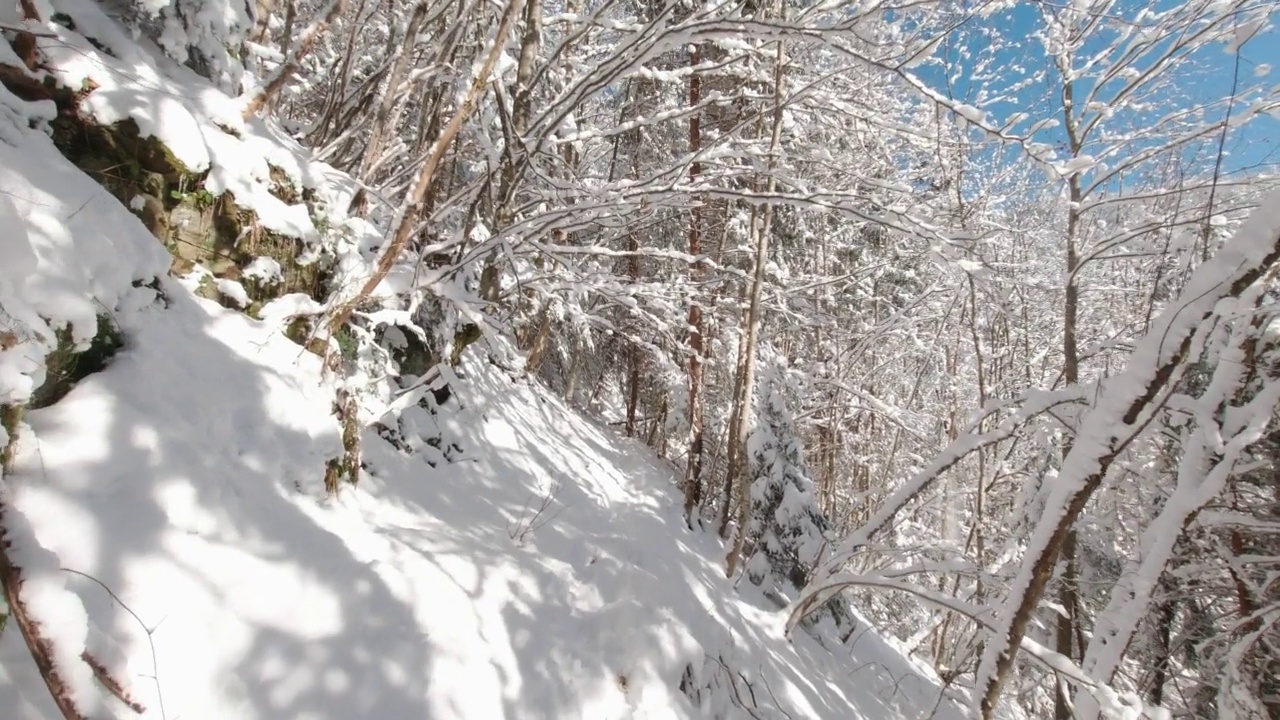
916;0;1280;172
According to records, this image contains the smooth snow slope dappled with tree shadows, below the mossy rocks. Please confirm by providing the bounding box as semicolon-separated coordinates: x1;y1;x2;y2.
0;304;962;720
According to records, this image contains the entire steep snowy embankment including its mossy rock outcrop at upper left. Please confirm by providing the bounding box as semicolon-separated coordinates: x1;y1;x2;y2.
0;3;951;720
